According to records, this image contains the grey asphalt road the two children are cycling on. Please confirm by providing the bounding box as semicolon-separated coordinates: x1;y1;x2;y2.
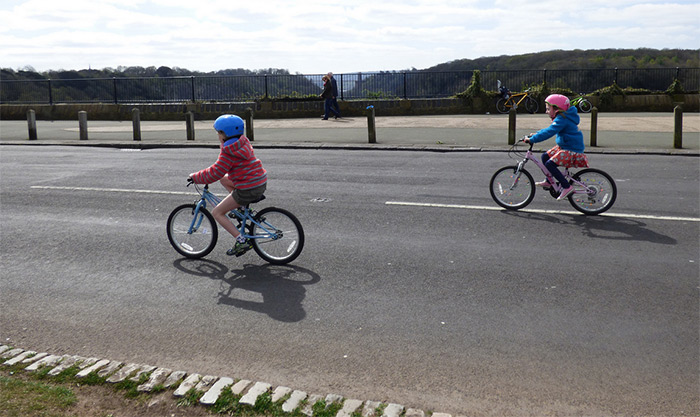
0;146;700;416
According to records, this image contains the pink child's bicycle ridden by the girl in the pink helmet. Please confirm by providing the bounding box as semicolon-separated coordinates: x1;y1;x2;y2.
490;136;617;215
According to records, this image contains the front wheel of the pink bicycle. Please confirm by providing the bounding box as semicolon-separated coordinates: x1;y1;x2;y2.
489;165;535;210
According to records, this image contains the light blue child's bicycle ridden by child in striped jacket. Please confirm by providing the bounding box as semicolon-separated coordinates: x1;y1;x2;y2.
167;184;304;265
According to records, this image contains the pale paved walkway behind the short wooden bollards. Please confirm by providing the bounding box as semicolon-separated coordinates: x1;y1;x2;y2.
0;113;700;155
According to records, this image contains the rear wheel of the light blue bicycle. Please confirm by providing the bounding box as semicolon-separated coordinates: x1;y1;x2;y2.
253;207;304;265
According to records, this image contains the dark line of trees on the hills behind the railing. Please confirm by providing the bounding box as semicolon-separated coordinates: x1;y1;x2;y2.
0;49;700;103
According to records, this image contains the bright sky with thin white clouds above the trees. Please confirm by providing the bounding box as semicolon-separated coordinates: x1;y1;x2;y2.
0;0;700;74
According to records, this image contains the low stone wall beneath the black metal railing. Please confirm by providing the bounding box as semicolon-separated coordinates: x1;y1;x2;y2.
0;94;700;120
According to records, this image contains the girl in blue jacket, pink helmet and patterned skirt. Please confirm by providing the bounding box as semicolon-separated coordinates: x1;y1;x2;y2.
525;94;588;200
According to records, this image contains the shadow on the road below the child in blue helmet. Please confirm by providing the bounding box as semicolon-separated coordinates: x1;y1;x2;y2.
174;258;321;323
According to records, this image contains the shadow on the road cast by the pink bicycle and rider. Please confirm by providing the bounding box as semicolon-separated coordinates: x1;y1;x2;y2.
504;210;678;245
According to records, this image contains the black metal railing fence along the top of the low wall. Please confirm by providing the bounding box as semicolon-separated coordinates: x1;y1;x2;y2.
0;68;700;104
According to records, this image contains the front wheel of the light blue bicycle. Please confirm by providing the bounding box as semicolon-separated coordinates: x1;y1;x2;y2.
166;204;219;259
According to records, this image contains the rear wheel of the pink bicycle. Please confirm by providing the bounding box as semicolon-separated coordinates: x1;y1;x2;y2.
568;168;617;216
